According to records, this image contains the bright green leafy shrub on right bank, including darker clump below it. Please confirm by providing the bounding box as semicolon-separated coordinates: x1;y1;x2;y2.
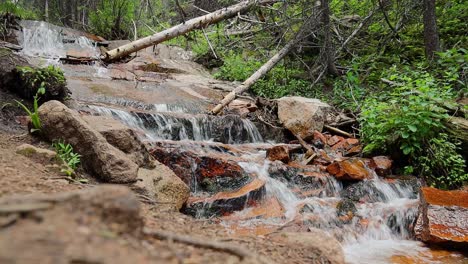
360;68;467;189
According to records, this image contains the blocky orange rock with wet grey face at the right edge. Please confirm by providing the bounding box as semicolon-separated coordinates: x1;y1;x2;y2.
415;187;468;246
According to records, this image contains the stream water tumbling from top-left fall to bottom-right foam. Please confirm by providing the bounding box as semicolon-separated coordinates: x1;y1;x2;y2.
22;20;464;264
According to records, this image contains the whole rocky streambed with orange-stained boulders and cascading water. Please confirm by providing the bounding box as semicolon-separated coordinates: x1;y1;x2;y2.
0;20;468;263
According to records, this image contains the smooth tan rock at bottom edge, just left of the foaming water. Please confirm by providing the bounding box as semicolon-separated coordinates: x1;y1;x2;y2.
268;228;345;264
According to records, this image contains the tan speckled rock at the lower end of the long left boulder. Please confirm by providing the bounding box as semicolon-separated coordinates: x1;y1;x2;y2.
135;167;190;211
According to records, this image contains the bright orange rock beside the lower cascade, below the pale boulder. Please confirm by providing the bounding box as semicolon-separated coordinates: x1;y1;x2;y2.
327;158;371;181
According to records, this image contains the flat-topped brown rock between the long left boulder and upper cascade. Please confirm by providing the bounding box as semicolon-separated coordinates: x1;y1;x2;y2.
82;115;153;168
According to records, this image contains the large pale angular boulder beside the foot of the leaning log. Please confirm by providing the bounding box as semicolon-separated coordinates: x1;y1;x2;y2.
278;96;332;139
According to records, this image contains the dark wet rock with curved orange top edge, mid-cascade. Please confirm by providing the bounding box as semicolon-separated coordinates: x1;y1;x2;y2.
182;179;266;218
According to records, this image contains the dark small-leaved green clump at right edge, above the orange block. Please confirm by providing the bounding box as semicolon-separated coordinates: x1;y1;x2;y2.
416;133;468;189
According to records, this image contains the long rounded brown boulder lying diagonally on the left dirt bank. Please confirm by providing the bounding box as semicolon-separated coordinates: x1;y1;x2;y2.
39;101;138;183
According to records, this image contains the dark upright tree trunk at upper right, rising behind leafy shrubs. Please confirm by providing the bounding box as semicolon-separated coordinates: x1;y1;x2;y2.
423;0;440;60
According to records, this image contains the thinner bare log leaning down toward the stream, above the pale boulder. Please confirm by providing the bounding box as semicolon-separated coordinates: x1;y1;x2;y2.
211;14;311;115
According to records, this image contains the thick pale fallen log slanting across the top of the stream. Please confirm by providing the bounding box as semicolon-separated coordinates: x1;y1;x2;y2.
103;0;262;61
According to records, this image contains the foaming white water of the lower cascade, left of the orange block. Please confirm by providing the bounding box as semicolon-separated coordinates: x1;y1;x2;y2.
232;157;437;264
